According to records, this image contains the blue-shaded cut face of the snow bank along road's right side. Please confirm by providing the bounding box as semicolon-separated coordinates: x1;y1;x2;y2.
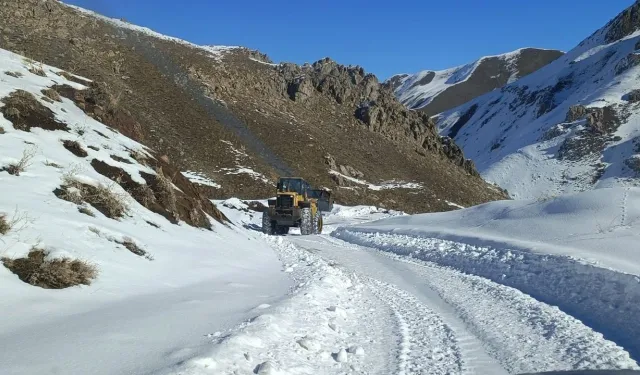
332;228;640;360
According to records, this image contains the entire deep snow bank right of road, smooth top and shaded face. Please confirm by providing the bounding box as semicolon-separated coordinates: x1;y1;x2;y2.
333;188;640;358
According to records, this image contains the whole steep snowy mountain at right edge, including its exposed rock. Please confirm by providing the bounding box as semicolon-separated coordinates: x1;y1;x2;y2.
437;2;640;198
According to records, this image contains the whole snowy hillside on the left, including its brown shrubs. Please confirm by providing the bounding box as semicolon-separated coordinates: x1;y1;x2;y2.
0;50;291;375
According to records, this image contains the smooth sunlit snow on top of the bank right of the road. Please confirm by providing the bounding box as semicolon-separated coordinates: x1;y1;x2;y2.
338;187;640;275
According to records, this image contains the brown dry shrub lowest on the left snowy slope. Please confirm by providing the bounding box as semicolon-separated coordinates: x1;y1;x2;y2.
2;248;98;289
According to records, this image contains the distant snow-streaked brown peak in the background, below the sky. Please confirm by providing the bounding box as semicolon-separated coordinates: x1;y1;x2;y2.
385;48;562;115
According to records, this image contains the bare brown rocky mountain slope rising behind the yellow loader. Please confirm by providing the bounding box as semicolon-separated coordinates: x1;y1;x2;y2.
0;0;504;211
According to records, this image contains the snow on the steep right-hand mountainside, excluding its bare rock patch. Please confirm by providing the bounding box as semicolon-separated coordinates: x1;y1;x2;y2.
437;20;640;199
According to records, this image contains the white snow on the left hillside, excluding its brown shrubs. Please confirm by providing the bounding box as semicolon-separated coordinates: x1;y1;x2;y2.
0;50;290;375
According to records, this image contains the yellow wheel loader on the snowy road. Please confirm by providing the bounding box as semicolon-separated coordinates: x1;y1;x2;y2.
262;177;333;235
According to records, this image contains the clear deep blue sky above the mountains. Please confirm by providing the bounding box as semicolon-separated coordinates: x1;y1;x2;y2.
65;0;633;79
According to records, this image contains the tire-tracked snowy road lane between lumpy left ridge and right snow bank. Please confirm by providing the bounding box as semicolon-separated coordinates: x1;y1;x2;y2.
289;236;634;374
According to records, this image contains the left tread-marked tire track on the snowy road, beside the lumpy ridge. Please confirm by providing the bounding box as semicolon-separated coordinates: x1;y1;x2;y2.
367;278;465;375
